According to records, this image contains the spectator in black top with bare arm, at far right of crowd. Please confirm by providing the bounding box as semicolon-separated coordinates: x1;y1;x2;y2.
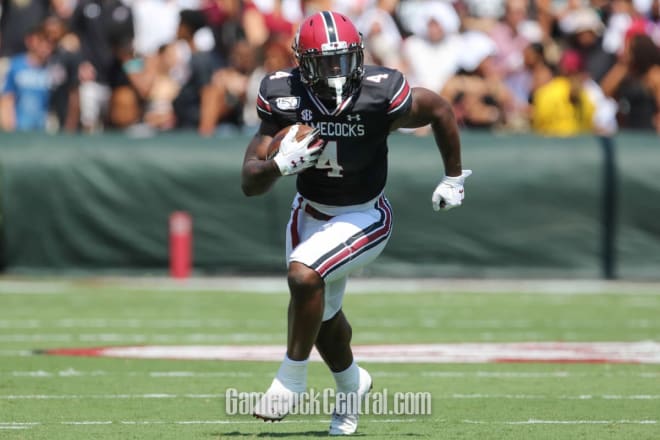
601;34;660;133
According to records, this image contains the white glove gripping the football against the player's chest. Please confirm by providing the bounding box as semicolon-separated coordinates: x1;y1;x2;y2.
273;124;325;176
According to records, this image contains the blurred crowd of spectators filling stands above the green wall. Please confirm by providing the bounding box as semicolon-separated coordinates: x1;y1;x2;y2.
0;0;660;136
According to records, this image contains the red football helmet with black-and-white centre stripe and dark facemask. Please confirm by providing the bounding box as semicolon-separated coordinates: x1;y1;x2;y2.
292;11;364;105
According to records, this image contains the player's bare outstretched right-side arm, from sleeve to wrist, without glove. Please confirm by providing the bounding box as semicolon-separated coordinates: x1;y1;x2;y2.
392;87;463;176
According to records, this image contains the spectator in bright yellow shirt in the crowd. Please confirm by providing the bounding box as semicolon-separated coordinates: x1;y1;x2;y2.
532;50;595;136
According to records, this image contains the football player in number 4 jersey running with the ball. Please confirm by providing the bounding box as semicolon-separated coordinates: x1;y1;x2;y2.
242;11;471;435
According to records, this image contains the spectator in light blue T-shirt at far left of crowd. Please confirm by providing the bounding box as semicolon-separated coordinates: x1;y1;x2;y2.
0;25;53;131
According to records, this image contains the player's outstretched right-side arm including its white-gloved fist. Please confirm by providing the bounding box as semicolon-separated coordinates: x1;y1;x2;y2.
392;87;472;211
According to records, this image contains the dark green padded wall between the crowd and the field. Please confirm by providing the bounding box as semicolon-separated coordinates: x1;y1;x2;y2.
0;132;660;279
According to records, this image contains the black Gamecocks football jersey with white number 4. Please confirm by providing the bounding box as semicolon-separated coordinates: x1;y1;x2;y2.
257;66;412;206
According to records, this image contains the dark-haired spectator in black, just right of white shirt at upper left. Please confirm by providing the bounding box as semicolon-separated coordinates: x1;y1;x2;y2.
172;9;217;136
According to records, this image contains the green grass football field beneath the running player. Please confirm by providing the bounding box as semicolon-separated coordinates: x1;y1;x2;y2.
0;279;660;440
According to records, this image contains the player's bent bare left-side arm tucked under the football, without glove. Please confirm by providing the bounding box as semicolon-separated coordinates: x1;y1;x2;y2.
241;121;281;196
